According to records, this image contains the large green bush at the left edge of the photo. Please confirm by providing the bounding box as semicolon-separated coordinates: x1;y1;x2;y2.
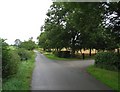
2;40;20;78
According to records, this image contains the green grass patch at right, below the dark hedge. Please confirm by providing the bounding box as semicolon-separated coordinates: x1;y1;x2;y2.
87;66;120;91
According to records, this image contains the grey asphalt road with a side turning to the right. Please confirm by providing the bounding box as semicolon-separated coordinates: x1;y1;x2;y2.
31;51;110;90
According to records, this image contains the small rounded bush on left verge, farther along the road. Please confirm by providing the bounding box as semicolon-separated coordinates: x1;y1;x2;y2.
18;48;32;61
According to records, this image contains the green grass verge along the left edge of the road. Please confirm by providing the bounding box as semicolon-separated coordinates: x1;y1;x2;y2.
2;52;35;90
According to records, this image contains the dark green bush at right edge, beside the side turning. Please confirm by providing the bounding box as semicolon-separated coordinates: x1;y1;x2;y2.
95;52;120;70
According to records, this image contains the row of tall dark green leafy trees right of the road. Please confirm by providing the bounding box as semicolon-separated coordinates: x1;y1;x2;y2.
38;2;120;55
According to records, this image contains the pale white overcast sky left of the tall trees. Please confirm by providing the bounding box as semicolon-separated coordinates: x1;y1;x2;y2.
0;0;52;44
